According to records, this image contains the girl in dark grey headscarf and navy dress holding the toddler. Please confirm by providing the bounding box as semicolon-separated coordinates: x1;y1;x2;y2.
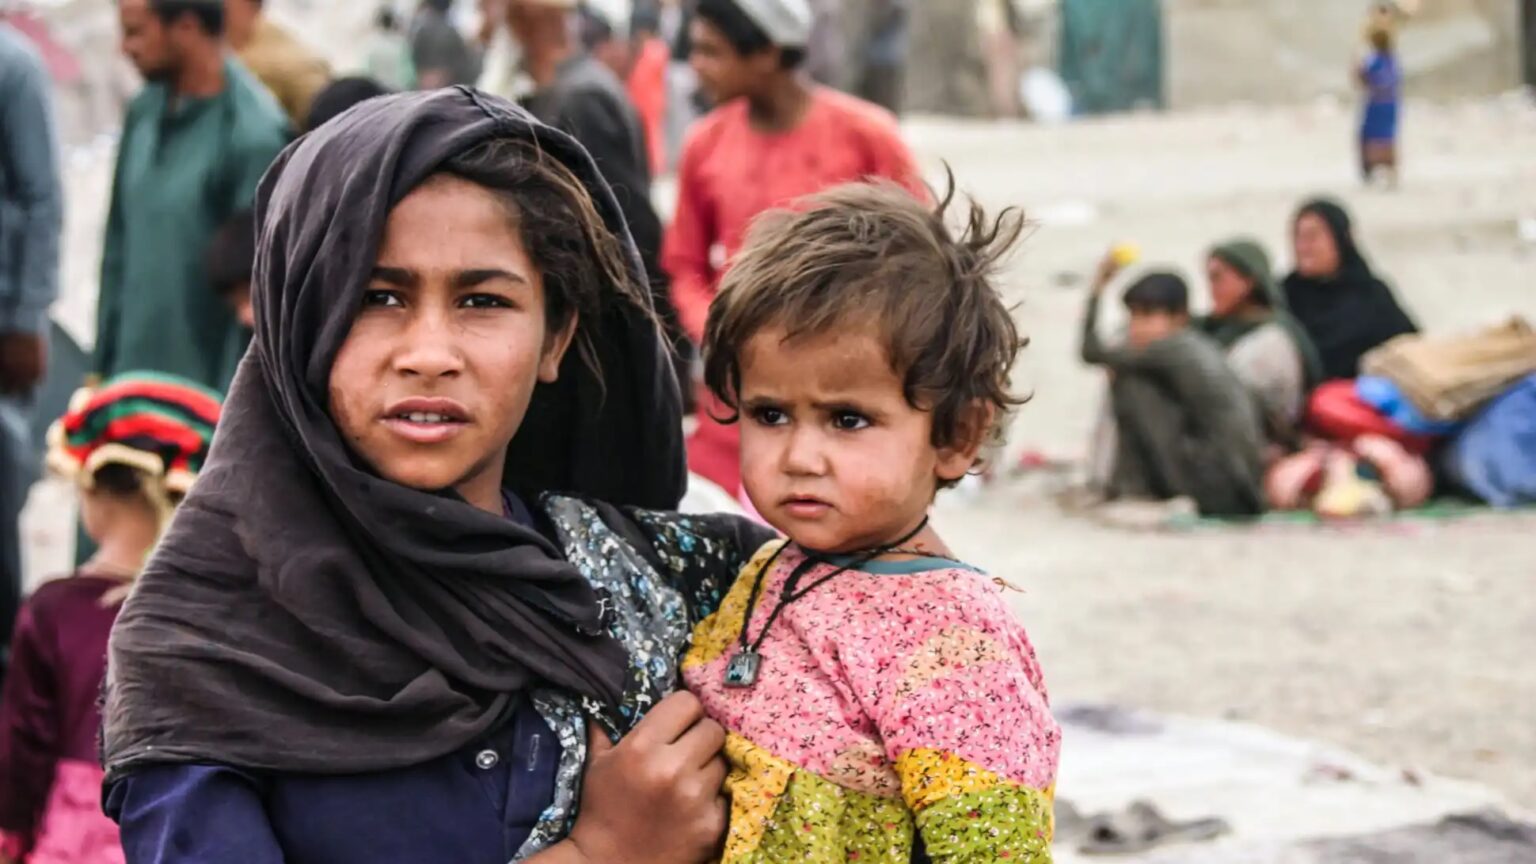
103;88;766;864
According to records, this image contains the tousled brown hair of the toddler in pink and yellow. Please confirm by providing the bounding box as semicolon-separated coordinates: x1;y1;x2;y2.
703;174;1026;464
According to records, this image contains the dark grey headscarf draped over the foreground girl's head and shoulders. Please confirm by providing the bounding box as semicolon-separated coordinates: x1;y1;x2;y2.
104;88;685;781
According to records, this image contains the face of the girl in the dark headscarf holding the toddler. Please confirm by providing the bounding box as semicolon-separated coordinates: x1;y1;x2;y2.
330;175;576;512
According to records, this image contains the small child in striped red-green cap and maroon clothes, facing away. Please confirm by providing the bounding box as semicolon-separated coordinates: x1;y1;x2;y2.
0;374;220;864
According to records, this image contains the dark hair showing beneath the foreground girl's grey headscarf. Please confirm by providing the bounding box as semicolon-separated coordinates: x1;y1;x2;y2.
442;138;659;377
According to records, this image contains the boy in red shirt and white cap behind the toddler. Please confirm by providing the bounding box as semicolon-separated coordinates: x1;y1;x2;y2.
662;0;928;495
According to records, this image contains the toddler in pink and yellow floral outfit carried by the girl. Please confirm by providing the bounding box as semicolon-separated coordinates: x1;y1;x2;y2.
684;178;1060;864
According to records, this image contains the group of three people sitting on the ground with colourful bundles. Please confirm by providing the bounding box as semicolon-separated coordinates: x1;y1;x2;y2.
1074;198;1536;527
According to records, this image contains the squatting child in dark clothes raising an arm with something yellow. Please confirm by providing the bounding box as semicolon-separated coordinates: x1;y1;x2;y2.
1083;257;1264;517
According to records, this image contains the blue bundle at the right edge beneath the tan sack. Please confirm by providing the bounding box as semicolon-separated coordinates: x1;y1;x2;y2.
1444;375;1536;507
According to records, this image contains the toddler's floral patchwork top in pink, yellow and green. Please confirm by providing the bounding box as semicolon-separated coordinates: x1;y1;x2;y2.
684;541;1061;864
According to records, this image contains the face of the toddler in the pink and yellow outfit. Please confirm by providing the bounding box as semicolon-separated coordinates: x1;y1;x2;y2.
740;327;975;552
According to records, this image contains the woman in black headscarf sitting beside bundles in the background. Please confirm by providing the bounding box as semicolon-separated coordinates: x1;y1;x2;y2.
1284;198;1418;380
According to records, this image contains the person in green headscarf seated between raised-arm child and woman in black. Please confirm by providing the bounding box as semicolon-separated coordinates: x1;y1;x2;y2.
1195;238;1322;444
